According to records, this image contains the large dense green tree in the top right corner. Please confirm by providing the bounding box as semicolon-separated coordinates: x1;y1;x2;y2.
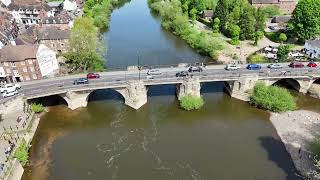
291;0;320;42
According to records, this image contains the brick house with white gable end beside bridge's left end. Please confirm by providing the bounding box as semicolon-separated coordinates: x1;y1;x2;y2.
0;45;59;82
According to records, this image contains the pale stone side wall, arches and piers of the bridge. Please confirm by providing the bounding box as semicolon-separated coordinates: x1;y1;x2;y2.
24;72;320;110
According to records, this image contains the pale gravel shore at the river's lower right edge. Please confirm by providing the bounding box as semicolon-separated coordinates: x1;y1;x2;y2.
270;110;320;176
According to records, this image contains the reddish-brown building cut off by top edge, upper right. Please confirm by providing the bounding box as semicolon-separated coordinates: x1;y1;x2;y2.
249;0;297;13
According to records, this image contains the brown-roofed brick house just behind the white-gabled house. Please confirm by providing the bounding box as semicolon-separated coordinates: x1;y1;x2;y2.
37;28;70;54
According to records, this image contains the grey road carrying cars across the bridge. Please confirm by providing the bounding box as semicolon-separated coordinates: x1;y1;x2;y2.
0;64;320;102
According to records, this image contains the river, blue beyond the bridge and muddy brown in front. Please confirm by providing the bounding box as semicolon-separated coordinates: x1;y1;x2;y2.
23;0;308;180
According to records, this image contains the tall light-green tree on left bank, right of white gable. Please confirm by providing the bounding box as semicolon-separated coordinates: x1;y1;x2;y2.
65;17;104;71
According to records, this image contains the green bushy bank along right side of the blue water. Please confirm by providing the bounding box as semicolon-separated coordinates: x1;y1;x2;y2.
148;0;224;59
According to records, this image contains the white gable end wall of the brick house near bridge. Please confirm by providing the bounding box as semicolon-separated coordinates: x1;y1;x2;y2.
36;44;59;77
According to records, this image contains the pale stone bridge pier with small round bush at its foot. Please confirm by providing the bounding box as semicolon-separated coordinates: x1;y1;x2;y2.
177;78;201;100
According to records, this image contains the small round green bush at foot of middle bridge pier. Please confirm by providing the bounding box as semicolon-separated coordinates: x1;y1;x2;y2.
180;95;204;111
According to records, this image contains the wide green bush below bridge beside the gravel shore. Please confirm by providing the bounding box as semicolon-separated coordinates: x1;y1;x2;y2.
250;83;296;112
